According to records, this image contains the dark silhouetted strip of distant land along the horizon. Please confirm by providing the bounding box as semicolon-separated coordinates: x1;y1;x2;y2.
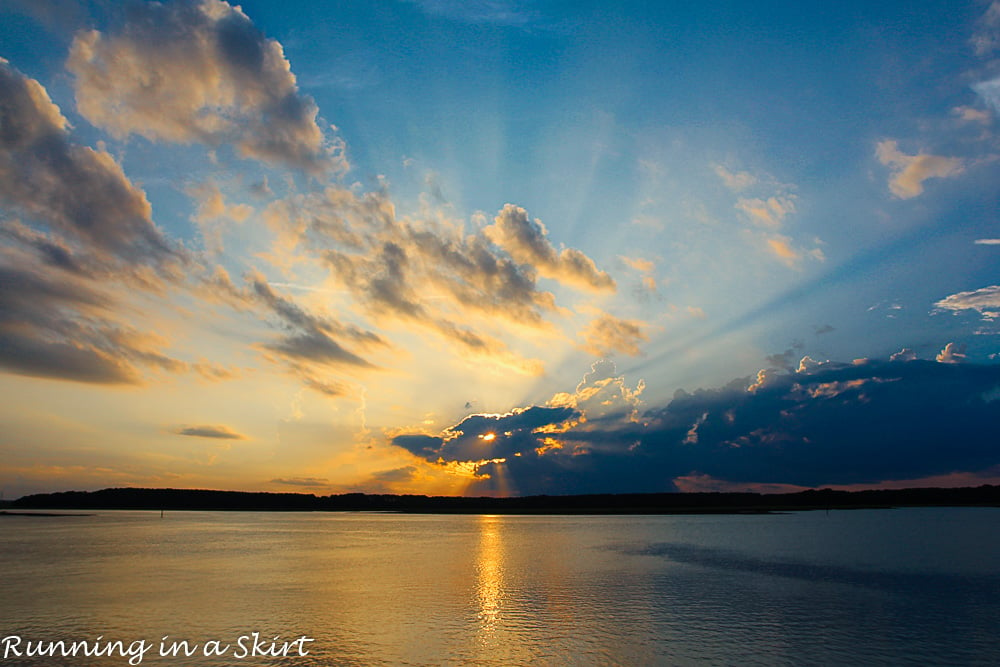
6;485;1000;514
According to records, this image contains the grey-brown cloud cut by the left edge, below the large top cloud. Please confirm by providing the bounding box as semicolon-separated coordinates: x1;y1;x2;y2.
0;58;182;264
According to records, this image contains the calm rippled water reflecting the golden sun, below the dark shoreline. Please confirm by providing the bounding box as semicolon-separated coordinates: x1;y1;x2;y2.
0;508;1000;667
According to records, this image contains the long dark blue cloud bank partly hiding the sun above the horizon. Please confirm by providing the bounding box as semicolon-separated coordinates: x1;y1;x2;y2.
393;360;1000;494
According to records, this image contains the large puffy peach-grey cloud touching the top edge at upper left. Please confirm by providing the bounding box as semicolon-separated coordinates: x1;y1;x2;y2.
66;0;346;173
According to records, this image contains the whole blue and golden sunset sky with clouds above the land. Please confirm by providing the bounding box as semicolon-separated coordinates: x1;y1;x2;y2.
0;0;1000;498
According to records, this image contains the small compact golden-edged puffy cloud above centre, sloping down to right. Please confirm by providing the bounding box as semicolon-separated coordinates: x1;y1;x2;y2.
483;204;615;292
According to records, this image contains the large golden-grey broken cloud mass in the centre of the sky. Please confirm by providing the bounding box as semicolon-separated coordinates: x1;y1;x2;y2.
263;186;613;375
